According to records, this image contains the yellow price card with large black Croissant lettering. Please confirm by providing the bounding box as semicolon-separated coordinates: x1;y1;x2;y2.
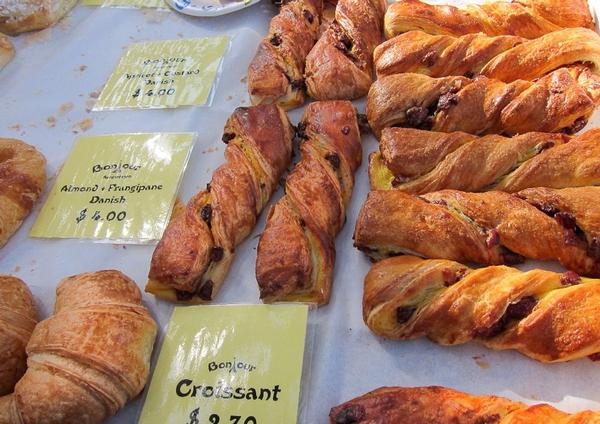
139;305;308;424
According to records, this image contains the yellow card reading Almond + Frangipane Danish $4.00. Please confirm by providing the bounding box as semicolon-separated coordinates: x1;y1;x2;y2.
30;133;195;243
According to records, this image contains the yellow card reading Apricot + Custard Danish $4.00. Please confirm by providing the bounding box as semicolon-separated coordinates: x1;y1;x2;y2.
94;37;229;110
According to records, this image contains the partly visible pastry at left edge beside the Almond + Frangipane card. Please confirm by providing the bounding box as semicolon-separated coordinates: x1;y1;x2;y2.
0;138;46;247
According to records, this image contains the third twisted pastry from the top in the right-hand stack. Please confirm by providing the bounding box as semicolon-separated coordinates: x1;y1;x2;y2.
367;65;600;136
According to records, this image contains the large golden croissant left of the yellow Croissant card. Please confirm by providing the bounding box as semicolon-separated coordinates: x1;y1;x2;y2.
0;271;156;424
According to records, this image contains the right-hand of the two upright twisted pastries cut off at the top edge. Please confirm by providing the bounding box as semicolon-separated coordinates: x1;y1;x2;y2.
305;0;387;100
